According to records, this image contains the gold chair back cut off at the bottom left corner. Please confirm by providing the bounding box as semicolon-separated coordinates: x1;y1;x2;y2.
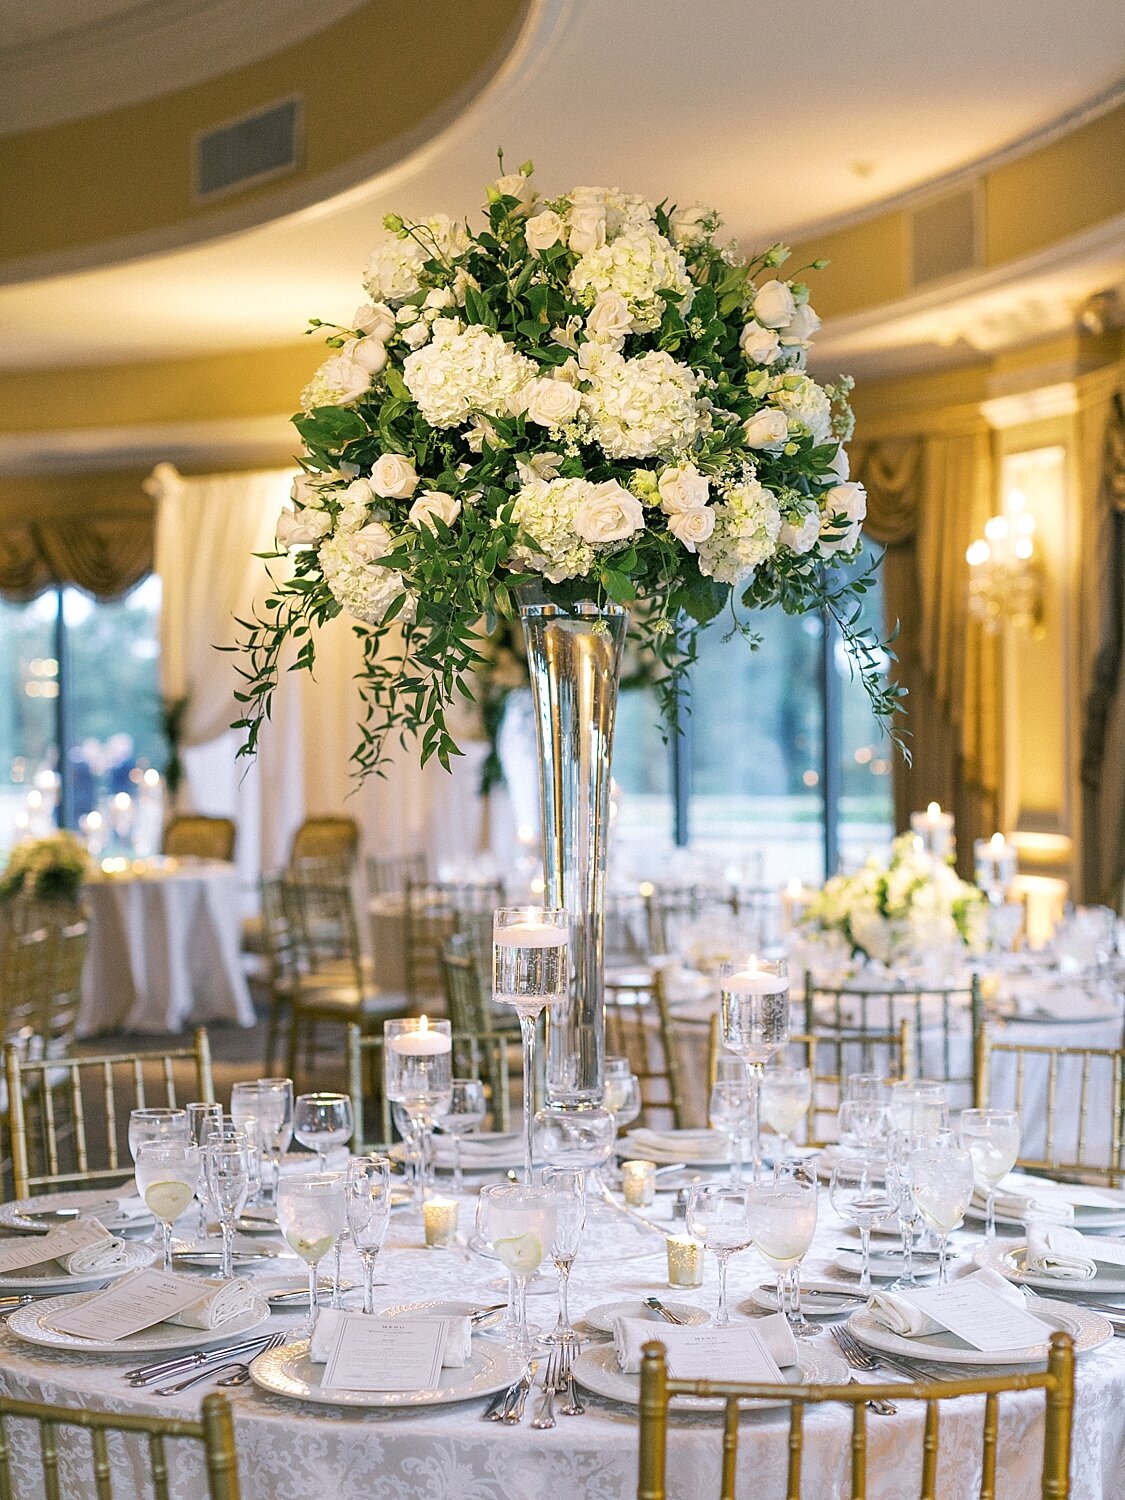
0;1391;242;1500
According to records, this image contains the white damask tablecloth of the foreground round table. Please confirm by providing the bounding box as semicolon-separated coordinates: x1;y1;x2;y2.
0;1196;1125;1500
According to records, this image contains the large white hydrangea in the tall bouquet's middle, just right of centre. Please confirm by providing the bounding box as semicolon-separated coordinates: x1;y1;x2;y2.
582;345;710;459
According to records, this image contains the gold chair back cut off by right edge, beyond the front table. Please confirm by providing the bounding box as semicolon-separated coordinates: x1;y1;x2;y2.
974;1023;1125;1188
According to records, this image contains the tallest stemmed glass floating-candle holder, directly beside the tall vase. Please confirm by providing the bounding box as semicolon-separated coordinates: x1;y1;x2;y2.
492;906;570;1184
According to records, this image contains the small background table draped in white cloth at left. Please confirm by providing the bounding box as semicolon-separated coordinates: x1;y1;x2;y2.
78;860;254;1037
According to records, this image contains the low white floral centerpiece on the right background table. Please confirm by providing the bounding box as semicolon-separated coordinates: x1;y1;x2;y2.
803;834;989;963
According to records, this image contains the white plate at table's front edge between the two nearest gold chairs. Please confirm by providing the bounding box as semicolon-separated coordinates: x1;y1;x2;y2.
251;1338;524;1407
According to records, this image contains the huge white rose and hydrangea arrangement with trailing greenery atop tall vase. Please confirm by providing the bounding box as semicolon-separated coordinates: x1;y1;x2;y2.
239;162;896;774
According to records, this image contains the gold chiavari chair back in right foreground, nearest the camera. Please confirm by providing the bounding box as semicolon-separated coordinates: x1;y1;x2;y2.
636;1334;1074;1500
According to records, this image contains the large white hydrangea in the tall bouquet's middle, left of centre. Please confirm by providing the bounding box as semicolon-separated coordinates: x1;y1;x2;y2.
402;318;539;428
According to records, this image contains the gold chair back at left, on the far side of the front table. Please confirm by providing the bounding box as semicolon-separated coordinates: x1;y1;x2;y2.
5;1028;215;1199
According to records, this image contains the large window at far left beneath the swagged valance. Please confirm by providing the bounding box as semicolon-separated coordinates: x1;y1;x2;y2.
0;578;165;848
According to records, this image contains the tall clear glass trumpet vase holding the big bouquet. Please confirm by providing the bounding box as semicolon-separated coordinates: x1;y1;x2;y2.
519;588;629;1110
